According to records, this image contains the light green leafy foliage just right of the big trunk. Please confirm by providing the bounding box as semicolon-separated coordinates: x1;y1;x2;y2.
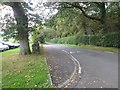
31;23;56;43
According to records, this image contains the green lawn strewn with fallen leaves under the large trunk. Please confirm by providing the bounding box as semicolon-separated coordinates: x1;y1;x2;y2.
1;49;52;88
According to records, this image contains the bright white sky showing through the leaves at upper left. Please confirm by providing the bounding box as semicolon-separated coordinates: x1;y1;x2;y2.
0;0;58;34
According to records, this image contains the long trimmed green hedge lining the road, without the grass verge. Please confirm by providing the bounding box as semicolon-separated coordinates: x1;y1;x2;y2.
51;32;120;48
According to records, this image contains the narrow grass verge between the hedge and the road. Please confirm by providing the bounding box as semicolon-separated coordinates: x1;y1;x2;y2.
64;44;119;53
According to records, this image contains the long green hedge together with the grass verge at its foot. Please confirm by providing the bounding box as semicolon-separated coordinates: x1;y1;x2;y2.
50;32;120;53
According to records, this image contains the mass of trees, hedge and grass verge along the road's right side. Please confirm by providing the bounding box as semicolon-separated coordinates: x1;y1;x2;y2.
44;2;120;52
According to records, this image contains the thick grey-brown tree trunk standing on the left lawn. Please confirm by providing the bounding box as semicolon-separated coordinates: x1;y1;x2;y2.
9;2;31;55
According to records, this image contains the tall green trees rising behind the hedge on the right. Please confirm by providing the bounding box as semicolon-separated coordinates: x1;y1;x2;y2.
47;2;120;37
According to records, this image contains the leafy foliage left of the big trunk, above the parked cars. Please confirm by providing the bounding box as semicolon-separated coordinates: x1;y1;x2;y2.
1;13;18;41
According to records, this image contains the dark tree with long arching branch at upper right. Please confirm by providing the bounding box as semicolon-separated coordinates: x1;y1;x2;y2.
62;2;119;33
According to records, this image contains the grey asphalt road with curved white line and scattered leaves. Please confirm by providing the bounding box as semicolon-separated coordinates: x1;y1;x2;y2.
44;44;118;88
